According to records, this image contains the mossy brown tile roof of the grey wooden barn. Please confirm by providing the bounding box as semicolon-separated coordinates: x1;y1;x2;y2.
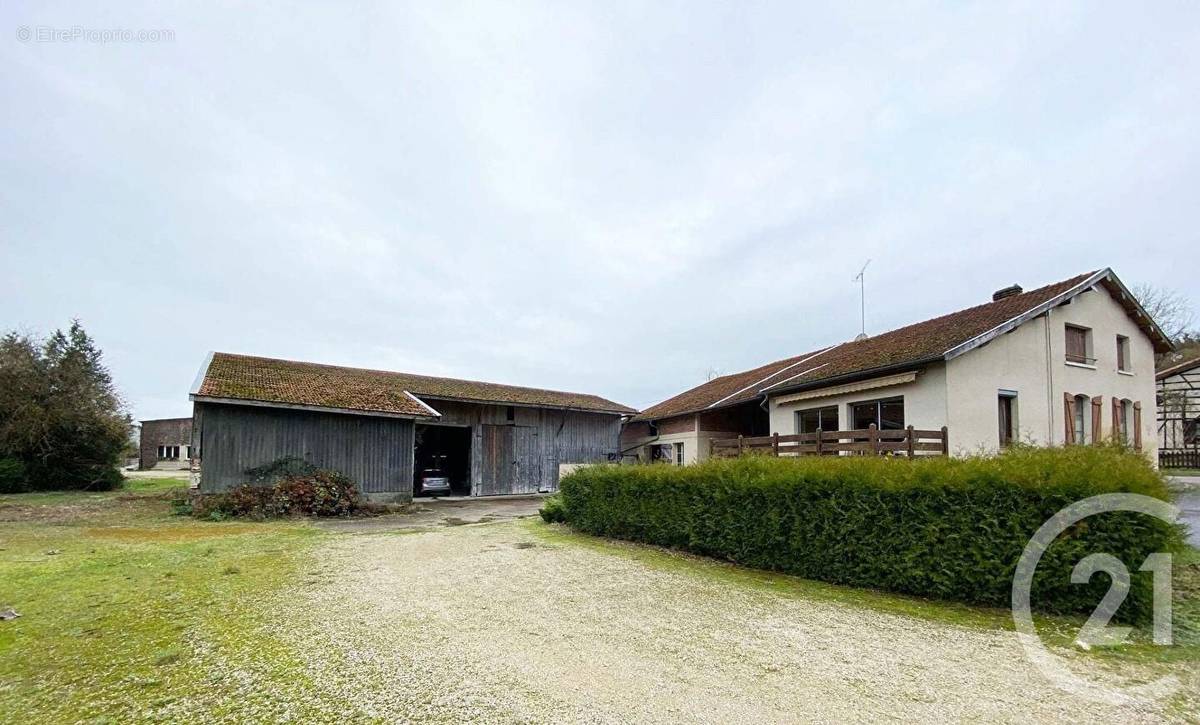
192;353;635;418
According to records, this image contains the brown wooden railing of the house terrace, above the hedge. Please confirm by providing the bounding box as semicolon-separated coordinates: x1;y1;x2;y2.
708;424;950;457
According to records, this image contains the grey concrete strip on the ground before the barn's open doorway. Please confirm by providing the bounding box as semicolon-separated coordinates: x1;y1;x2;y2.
317;493;548;533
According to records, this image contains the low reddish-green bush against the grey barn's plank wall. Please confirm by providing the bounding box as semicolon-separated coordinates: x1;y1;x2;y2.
192;469;362;521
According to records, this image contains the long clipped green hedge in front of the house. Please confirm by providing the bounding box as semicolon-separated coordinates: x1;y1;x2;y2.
560;447;1182;621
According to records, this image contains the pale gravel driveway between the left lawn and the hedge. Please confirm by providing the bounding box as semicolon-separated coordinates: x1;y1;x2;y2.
276;522;1185;723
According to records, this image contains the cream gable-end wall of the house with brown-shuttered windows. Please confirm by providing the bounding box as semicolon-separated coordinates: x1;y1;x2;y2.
946;288;1158;460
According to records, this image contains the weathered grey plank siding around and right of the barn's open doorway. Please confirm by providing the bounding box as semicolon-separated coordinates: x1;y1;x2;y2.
422;396;620;496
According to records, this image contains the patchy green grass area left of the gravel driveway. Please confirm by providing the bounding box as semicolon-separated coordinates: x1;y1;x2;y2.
0;479;340;723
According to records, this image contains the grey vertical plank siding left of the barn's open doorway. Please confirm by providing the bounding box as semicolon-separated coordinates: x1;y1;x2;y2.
193;402;414;498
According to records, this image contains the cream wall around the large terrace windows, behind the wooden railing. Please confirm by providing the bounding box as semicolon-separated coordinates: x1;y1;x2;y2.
768;363;954;443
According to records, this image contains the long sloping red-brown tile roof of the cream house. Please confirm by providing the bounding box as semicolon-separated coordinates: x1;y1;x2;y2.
636;270;1162;420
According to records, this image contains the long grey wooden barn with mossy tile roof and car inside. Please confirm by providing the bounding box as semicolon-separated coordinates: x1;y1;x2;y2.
191;353;635;502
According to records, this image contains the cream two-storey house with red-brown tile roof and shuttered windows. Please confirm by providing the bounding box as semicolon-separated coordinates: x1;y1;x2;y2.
623;269;1171;463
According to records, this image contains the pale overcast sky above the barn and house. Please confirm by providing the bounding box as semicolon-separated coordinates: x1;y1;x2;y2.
0;1;1200;419
